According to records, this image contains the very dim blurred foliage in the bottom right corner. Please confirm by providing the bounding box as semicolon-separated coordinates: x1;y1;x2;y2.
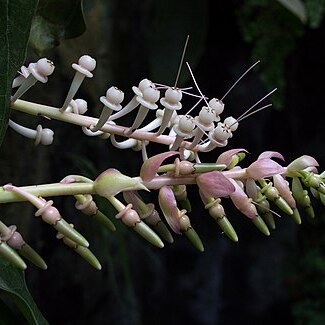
287;210;325;325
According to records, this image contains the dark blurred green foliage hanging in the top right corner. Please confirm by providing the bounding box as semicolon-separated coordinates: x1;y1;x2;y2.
237;0;325;108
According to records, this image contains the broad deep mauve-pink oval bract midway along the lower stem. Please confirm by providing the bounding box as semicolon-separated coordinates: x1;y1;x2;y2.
196;171;235;198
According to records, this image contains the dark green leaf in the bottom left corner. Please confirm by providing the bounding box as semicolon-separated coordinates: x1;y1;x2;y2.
0;258;48;325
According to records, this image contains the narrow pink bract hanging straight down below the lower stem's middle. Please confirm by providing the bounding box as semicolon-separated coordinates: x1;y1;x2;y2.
158;186;181;234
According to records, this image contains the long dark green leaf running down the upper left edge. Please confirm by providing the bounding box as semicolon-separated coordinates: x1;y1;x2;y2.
0;0;37;144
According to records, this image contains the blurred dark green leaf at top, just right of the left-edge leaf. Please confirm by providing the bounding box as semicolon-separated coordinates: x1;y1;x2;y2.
30;0;86;54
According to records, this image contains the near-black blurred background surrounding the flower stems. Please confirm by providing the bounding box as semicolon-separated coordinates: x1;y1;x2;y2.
1;0;325;325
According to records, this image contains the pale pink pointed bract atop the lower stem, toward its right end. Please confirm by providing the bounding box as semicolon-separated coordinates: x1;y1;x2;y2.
246;158;285;180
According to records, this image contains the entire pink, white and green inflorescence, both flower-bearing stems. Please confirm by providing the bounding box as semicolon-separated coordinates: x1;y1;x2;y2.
0;55;325;269
